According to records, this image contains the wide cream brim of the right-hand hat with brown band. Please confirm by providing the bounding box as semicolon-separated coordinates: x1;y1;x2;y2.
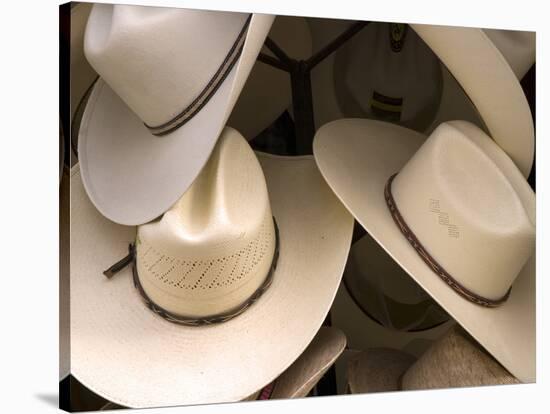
313;119;535;382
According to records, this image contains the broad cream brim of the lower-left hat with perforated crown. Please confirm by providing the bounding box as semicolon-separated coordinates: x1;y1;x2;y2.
71;154;353;407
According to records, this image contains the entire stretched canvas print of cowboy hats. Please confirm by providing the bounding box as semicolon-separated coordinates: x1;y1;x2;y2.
59;2;536;412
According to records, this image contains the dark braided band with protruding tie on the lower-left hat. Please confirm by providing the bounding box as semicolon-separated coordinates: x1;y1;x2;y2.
103;218;279;326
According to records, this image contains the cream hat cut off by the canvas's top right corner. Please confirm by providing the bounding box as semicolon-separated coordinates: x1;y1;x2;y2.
411;24;535;177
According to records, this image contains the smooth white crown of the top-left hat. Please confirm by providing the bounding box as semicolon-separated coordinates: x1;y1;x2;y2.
84;4;248;126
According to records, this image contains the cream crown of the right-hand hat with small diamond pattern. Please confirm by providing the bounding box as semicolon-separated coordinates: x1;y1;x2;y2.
392;121;535;300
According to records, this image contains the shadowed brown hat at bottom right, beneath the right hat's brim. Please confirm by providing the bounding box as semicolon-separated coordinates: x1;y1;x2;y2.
348;326;519;394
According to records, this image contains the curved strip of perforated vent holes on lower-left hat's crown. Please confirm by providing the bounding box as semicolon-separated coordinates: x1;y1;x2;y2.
137;218;274;290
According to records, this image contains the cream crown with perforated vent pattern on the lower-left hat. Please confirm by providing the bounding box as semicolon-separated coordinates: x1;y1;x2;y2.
137;128;275;318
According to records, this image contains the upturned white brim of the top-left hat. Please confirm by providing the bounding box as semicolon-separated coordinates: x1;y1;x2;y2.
78;14;274;225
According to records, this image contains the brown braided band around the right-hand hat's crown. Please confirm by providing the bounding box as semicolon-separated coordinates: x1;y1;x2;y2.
384;173;512;308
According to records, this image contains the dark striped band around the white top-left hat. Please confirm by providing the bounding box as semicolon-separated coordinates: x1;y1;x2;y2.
145;14;252;136
